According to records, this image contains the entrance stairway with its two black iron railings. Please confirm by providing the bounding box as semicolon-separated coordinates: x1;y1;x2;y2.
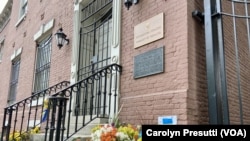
0;64;122;141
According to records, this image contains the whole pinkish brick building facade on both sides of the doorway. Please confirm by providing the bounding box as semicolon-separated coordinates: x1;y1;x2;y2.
0;0;249;139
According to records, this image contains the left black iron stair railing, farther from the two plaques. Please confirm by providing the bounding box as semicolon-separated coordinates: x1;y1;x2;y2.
1;81;70;141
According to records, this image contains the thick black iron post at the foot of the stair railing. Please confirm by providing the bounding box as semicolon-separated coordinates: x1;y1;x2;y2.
49;96;68;141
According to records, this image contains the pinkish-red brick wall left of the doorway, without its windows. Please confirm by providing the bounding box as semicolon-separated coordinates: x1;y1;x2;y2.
0;0;74;127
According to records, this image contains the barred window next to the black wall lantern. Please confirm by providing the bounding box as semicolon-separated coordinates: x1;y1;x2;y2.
34;36;52;92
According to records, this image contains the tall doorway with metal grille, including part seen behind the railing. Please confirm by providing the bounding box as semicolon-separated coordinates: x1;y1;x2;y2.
75;0;112;115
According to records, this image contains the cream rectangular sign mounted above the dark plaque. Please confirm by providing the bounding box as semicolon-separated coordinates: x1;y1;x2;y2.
134;13;164;48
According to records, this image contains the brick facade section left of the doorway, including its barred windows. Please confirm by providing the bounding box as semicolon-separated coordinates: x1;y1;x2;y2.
0;0;73;138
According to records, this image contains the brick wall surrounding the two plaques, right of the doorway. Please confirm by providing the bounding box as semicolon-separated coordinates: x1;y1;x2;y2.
120;0;207;124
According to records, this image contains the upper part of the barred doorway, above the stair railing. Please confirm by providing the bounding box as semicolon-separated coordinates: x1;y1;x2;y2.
78;0;112;80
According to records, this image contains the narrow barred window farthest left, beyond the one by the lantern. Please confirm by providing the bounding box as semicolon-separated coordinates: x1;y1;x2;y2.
8;59;20;105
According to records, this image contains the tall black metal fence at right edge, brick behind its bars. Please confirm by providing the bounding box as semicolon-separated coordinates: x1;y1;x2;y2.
204;0;250;124
